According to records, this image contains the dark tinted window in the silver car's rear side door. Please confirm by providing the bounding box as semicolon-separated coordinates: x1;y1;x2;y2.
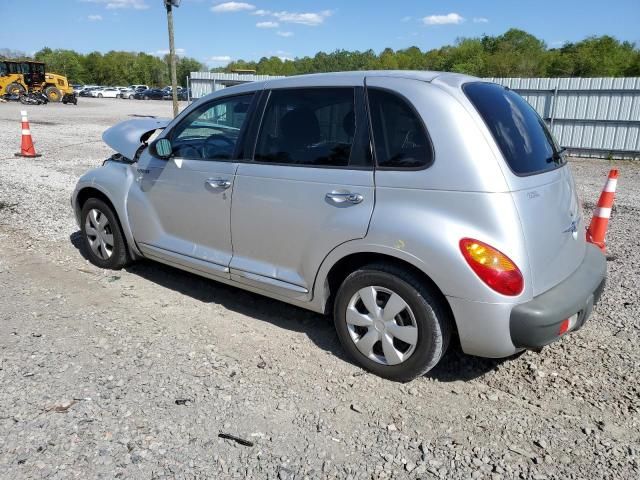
254;88;364;167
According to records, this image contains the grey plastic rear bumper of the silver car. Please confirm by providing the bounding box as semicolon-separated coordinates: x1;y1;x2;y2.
509;245;607;348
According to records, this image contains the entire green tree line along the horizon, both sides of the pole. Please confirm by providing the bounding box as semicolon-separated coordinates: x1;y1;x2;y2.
0;29;640;86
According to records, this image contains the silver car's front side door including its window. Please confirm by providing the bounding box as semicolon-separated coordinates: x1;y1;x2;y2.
128;94;253;277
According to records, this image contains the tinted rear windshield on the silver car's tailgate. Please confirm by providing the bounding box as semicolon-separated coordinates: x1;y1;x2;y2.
463;82;564;175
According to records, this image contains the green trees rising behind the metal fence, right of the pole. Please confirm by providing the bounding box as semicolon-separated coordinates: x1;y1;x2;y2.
221;29;640;77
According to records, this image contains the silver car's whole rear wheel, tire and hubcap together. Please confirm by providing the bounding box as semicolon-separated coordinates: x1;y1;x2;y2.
334;264;451;382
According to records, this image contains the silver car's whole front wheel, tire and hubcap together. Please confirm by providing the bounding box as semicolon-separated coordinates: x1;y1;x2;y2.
80;198;131;270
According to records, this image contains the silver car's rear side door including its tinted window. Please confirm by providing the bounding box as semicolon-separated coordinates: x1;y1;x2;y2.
231;86;374;299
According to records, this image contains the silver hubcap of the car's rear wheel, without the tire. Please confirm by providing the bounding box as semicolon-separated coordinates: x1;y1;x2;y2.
346;287;418;365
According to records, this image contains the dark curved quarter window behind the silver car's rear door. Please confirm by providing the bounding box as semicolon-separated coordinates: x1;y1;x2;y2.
367;88;433;169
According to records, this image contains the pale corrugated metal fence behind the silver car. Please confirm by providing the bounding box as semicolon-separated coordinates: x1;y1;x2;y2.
190;72;640;159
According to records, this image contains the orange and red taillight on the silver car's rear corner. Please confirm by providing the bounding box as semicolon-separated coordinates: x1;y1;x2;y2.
460;238;524;296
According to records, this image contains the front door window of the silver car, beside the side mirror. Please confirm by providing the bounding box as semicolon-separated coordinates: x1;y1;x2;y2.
171;94;253;160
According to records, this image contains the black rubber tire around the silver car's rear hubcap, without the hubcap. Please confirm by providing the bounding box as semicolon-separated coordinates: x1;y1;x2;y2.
333;263;452;382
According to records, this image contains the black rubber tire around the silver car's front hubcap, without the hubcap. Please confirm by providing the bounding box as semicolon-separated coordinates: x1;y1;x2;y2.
80;198;131;270
